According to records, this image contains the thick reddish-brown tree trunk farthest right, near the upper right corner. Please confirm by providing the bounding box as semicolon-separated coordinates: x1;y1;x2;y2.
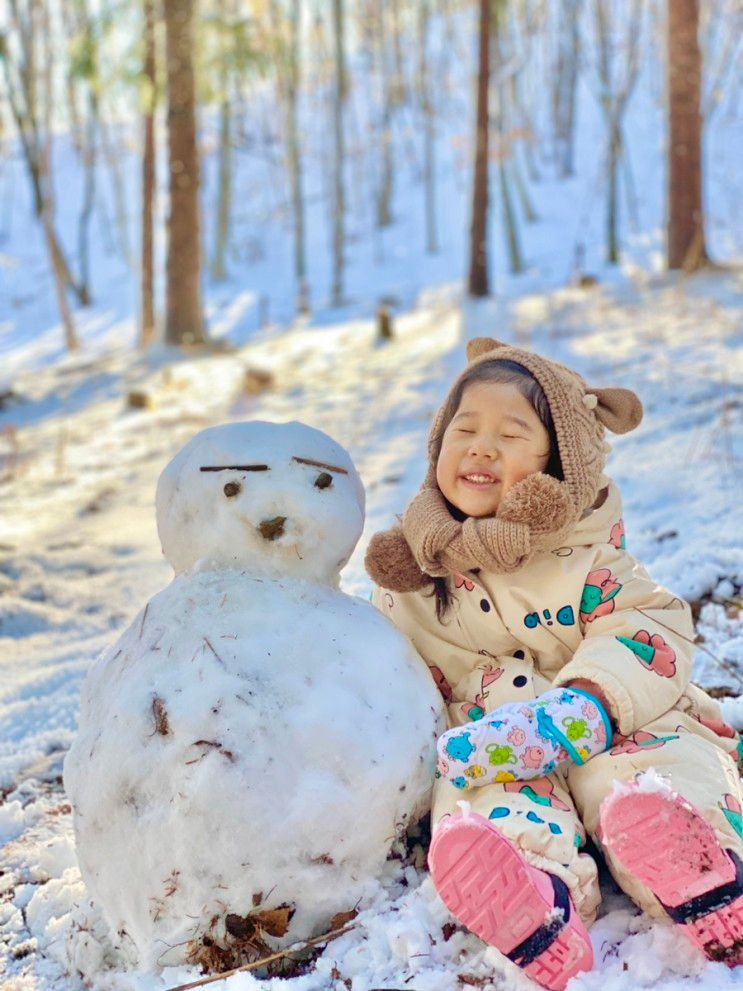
667;0;707;271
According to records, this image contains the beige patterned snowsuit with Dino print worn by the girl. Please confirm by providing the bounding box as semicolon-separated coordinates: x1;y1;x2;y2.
373;483;743;923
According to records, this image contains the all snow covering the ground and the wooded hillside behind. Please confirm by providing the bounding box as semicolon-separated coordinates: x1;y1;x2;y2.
0;5;743;991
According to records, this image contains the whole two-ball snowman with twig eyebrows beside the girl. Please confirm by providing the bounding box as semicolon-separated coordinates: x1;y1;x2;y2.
64;421;442;969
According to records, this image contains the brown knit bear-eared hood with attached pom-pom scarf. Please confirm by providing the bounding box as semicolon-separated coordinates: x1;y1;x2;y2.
365;337;642;592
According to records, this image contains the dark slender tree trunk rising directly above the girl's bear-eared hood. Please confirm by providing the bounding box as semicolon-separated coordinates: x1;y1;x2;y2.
468;0;490;296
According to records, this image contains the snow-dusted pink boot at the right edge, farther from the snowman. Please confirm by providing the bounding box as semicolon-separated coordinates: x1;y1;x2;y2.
601;788;743;967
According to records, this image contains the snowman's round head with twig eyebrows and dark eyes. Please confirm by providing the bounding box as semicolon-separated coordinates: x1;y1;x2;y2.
157;420;364;585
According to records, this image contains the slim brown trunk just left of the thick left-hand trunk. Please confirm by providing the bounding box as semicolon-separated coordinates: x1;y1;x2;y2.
139;0;157;347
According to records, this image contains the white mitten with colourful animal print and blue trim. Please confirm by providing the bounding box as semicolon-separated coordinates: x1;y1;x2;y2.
438;688;612;788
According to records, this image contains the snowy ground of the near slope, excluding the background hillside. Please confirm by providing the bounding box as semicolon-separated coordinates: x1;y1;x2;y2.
0;260;743;991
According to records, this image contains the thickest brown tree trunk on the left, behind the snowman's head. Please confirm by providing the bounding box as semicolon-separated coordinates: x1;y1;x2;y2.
164;0;205;344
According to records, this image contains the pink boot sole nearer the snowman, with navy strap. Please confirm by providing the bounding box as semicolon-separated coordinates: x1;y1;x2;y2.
428;813;593;991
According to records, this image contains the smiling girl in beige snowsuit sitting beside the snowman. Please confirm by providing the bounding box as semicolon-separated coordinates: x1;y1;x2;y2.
366;339;743;989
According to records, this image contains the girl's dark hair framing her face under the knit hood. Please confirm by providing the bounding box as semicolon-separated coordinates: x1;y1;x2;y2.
430;358;563;620
